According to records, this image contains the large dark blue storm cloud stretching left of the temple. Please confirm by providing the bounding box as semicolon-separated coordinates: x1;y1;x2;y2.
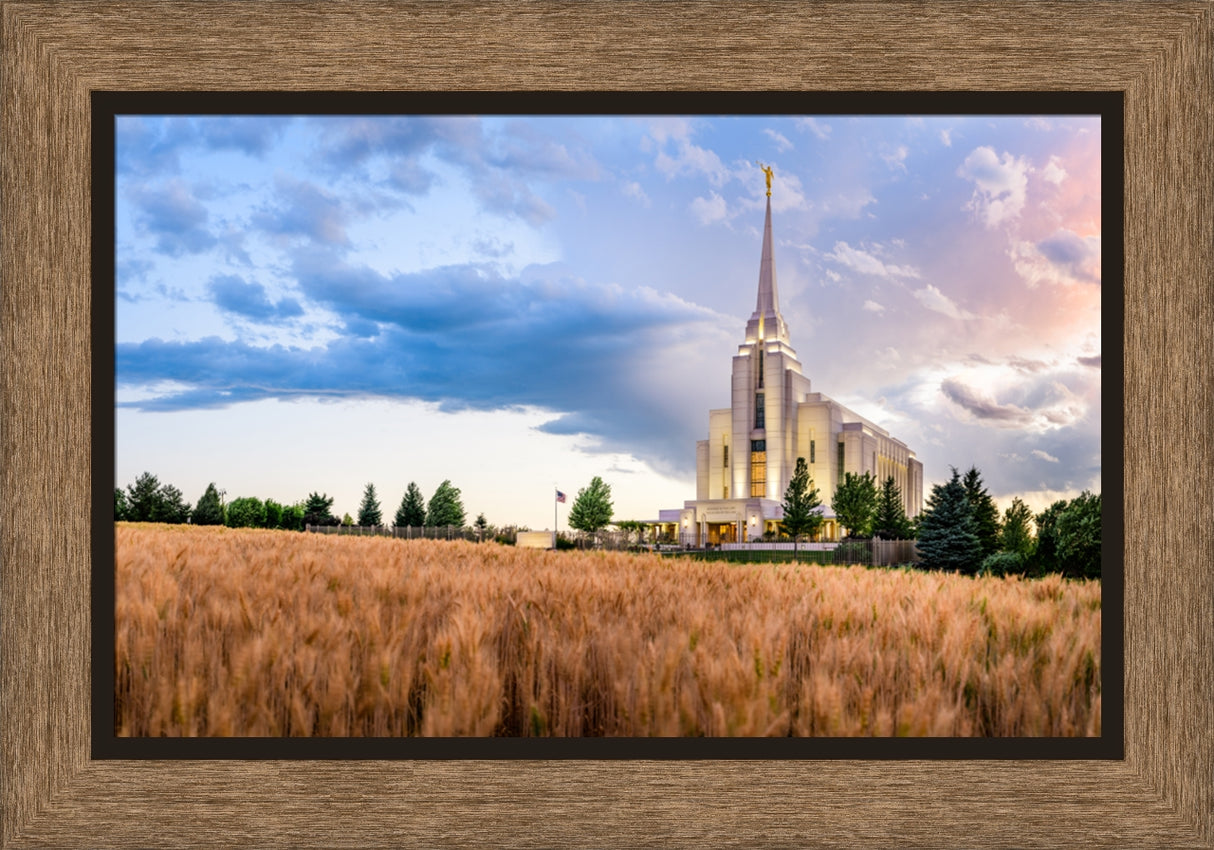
117;255;717;469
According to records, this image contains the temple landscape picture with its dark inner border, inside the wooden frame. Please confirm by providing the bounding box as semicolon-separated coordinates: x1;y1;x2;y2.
92;92;1123;759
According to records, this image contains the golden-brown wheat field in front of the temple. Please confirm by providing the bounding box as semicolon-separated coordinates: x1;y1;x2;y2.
114;523;1100;736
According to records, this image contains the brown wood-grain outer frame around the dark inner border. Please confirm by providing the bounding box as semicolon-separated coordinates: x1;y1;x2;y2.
0;0;1214;848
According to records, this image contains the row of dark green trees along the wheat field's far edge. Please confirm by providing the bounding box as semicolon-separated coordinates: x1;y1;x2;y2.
114;458;1101;578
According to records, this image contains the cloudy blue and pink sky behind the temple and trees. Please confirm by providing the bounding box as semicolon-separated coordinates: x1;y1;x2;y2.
115;115;1101;528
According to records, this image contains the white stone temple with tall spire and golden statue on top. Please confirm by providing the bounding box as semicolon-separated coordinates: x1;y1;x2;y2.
660;178;923;545
